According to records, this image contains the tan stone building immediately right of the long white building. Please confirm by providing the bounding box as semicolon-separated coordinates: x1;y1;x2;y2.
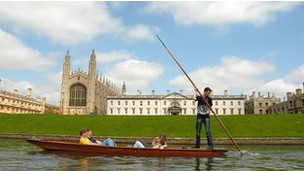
245;92;281;114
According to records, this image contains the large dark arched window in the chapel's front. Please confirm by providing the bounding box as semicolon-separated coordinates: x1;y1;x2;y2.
69;84;87;106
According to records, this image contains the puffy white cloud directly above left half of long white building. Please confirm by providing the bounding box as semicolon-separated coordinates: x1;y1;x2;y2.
105;59;164;91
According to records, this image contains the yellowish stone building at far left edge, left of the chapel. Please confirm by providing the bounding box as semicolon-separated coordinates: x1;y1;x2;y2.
0;88;46;113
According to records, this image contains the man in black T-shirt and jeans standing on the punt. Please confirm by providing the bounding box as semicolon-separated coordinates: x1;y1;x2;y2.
193;87;213;150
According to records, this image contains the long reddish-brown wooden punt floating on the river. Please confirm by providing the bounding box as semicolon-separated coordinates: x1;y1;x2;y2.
26;139;227;157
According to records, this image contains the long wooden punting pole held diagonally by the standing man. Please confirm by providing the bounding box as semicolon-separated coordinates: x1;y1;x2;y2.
156;35;243;155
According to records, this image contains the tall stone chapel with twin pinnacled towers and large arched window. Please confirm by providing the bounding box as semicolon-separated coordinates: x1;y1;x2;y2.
60;50;120;115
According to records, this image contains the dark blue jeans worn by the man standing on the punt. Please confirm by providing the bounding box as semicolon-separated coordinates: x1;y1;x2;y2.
195;114;213;148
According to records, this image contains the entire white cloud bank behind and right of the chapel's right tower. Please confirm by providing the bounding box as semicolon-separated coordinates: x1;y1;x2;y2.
74;50;164;93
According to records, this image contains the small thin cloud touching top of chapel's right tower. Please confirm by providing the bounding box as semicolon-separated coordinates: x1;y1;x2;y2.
96;50;132;64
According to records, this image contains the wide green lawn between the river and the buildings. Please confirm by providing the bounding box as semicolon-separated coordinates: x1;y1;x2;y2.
0;114;304;137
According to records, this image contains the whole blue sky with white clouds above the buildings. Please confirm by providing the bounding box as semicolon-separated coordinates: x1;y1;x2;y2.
0;2;304;104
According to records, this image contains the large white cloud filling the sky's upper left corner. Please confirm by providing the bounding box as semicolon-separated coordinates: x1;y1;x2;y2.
0;2;157;44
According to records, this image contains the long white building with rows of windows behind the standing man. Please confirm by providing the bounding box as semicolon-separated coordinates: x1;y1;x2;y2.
107;88;246;115
